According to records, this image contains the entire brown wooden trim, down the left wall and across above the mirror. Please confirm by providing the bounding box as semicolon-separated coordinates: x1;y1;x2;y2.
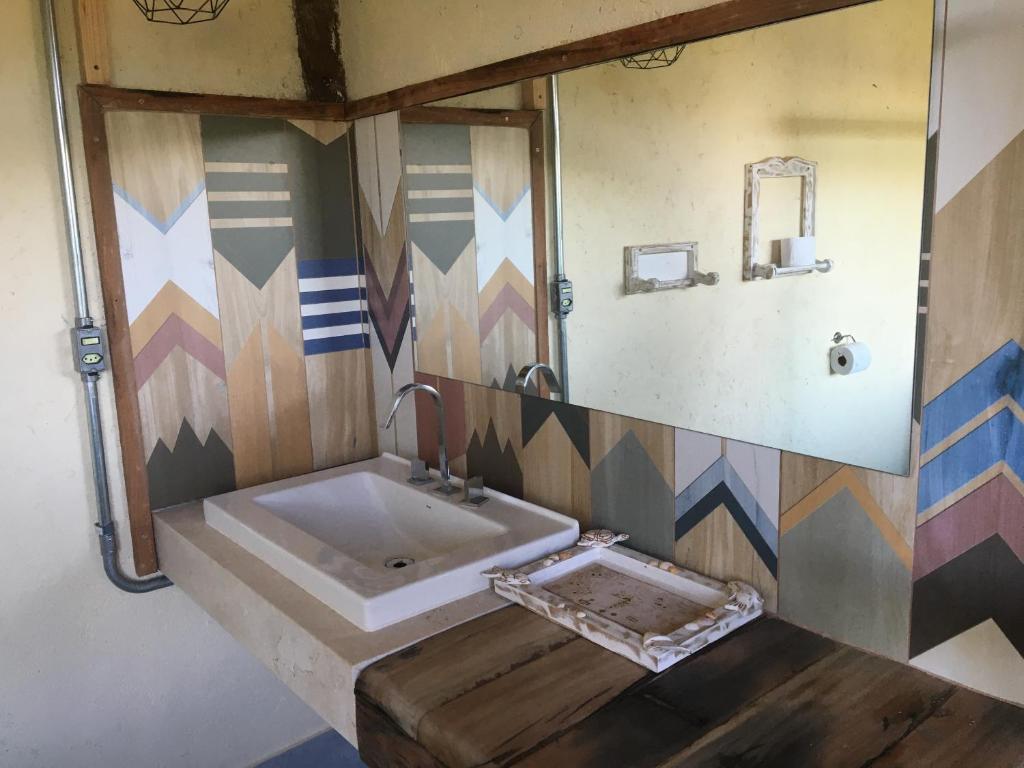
79;0;880;575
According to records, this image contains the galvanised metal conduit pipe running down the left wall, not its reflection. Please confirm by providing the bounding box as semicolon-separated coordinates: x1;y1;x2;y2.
42;0;171;594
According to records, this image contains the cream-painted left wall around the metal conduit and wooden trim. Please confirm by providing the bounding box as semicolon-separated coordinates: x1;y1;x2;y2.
0;0;324;768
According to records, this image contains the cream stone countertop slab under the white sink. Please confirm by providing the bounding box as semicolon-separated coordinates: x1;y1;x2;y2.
154;503;508;744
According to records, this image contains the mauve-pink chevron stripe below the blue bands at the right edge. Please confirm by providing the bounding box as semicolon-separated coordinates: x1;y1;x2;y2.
913;475;1024;581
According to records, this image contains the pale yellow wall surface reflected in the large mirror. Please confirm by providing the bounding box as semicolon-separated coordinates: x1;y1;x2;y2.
559;0;932;473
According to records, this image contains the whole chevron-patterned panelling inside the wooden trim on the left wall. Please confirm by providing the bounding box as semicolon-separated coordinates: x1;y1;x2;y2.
105;112;377;524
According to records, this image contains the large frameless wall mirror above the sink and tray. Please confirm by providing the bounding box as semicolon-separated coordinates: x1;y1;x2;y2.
402;0;934;474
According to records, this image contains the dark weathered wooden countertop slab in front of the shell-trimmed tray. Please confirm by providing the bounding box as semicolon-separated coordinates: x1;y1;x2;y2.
356;606;1024;768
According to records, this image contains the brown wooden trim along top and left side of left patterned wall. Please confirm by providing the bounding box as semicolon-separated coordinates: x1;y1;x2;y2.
79;85;347;575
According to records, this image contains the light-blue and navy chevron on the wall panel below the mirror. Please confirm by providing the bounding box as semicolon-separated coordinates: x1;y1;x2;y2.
676;456;778;575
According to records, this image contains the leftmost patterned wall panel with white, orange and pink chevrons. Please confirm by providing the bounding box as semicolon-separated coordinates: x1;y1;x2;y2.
106;113;236;508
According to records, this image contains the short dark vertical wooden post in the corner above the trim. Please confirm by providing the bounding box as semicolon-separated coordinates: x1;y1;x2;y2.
292;0;345;101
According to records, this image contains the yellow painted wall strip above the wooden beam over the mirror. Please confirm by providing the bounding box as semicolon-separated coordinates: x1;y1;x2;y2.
340;0;715;98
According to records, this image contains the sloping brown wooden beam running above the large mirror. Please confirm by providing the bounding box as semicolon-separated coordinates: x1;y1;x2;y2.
345;0;878;120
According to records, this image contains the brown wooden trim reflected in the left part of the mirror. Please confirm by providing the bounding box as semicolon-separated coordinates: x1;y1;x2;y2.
398;106;551;384
